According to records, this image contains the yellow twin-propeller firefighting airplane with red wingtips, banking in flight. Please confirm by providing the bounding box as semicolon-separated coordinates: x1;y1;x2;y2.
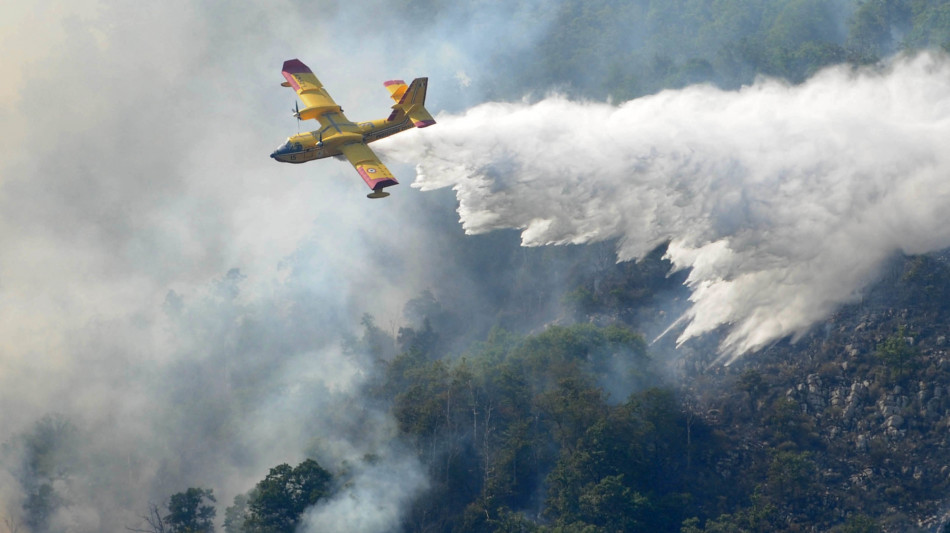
270;59;435;198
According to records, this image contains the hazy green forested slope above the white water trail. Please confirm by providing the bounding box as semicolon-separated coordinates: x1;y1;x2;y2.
488;0;950;101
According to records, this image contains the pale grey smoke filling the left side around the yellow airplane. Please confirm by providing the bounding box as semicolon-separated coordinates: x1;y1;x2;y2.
0;1;544;532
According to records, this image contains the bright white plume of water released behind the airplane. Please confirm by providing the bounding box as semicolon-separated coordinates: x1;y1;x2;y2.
386;54;950;360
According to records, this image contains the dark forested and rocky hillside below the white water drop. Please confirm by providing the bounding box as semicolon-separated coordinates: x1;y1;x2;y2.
130;251;950;533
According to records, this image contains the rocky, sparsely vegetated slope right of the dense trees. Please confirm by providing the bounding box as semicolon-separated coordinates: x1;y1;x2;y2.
608;251;950;531
